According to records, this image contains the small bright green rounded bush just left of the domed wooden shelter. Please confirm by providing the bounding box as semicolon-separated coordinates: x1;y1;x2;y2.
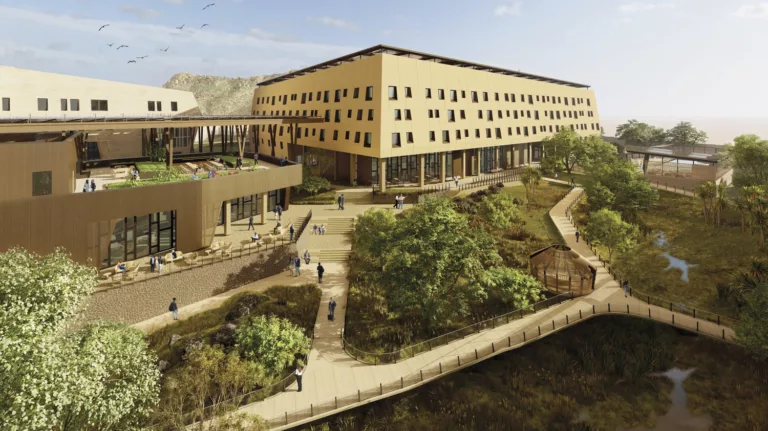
483;267;545;310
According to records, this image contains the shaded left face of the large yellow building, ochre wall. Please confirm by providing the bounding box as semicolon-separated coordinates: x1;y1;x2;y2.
253;55;389;157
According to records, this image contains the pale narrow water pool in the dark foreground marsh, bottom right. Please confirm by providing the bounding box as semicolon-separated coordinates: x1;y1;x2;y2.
630;368;712;431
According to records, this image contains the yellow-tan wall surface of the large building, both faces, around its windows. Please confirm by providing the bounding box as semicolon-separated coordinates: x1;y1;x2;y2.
253;54;600;157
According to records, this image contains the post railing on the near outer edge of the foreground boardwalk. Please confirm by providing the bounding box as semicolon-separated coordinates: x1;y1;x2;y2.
269;303;734;427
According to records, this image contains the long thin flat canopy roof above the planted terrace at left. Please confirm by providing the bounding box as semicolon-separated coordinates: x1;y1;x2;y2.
0;115;325;133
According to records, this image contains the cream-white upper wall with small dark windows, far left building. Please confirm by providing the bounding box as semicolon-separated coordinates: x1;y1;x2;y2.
0;66;197;118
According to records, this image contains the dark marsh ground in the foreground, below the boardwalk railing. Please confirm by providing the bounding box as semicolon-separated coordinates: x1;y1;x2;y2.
302;316;768;431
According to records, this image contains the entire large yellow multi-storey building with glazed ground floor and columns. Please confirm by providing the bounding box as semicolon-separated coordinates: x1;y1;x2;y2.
253;45;600;190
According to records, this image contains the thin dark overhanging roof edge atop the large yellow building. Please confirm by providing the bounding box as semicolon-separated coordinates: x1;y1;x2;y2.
259;45;590;88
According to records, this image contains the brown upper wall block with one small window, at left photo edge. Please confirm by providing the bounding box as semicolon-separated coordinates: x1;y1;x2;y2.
0;140;77;202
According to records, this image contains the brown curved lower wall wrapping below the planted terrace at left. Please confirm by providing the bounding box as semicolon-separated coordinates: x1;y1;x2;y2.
0;165;302;266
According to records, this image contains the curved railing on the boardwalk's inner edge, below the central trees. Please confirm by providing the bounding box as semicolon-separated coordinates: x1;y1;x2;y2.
341;292;573;365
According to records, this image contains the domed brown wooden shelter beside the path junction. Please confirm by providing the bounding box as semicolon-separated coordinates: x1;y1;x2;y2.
530;245;597;295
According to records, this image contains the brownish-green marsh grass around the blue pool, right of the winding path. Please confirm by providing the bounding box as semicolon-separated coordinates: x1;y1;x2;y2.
574;186;766;317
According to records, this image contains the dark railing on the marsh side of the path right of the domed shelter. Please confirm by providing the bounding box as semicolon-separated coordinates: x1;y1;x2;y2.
565;190;738;327
